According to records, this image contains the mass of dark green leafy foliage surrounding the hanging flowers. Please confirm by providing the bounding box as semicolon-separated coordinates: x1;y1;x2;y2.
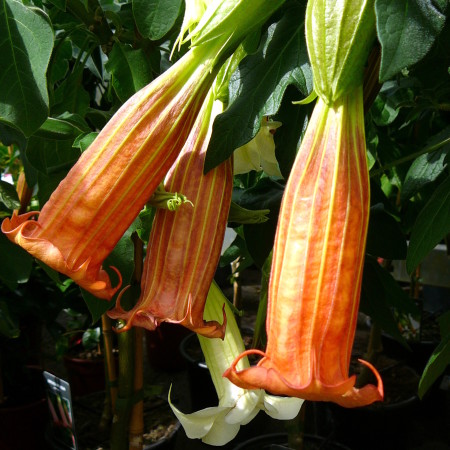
0;0;450;400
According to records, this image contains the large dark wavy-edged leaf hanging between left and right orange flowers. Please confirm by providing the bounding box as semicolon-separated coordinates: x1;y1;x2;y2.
205;4;312;172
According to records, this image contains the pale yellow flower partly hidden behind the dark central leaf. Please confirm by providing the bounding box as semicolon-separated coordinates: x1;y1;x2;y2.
233;117;281;177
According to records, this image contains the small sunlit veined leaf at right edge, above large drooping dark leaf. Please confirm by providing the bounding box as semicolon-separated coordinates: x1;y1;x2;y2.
401;127;450;201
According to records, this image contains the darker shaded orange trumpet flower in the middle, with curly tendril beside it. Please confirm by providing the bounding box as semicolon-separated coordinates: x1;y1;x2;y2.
108;90;233;337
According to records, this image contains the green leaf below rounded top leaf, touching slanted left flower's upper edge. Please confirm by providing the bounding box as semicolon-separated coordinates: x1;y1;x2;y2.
105;42;152;102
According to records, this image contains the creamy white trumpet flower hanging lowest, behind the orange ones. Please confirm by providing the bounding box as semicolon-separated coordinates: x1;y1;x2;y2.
169;283;303;445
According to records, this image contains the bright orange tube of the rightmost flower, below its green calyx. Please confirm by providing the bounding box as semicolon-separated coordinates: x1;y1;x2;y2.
224;91;383;407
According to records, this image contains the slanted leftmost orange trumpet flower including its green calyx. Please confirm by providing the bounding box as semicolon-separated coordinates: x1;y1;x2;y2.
1;0;282;299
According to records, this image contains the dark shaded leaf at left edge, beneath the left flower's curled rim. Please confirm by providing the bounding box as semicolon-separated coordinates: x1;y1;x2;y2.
0;229;33;289
